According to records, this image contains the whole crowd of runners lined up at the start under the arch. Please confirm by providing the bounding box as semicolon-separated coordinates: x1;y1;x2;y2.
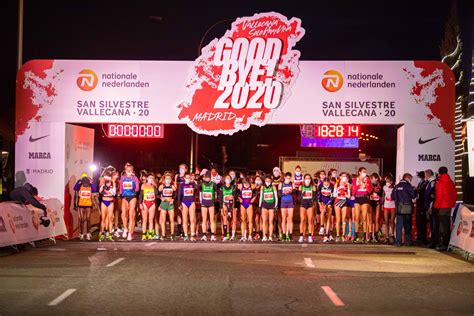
74;163;408;243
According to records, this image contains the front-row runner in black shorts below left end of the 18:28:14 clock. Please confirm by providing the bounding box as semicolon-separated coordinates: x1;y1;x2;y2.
298;174;317;243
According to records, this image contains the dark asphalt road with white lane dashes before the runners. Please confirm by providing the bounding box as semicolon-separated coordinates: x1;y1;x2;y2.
0;241;474;316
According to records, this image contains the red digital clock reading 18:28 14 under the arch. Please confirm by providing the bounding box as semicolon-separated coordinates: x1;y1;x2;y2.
301;124;360;138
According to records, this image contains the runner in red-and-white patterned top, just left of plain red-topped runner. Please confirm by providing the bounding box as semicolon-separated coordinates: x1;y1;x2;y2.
334;172;351;242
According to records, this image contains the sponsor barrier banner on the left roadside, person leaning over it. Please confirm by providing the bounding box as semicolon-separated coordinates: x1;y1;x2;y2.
0;199;66;247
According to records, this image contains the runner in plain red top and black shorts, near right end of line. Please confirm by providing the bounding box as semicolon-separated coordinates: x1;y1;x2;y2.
352;167;372;243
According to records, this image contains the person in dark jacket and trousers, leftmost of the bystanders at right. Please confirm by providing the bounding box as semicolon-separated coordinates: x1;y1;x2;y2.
392;173;416;246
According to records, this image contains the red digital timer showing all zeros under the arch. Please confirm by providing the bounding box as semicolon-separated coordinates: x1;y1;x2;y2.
107;123;163;138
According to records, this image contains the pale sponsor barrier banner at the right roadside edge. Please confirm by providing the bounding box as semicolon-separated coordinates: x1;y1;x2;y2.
449;204;474;258
